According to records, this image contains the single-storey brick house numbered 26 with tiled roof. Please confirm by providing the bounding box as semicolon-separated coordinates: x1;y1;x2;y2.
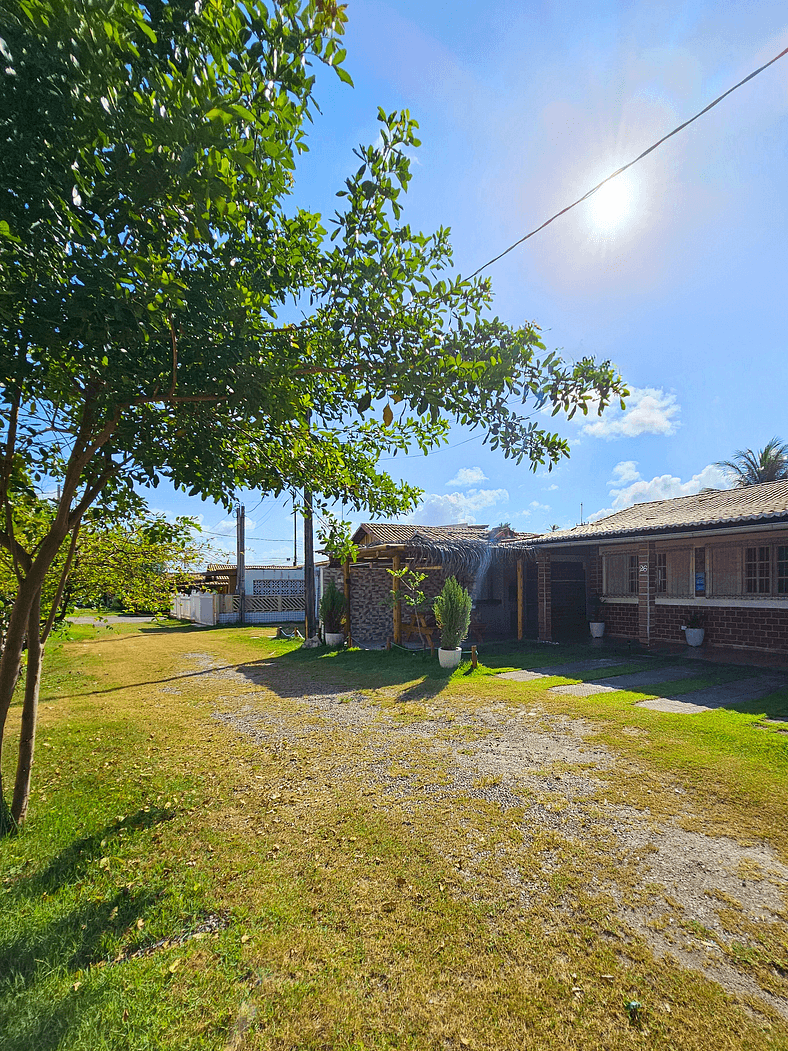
531;480;788;652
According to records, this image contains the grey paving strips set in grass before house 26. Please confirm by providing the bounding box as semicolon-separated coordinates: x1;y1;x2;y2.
498;658;788;715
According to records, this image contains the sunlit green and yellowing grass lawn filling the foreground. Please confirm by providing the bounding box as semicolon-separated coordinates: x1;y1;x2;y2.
0;624;788;1051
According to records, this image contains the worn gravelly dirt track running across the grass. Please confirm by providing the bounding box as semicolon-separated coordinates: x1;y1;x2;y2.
191;654;788;1017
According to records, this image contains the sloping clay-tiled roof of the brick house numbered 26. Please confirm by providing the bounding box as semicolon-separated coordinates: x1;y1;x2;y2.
533;479;788;543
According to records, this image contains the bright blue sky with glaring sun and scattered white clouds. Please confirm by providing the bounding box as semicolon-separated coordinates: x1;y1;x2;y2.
151;0;788;562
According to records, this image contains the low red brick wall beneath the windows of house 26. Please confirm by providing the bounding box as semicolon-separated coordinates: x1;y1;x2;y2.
651;605;788;652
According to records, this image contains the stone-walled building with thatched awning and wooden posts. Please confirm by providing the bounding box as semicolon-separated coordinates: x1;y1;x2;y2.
324;522;538;644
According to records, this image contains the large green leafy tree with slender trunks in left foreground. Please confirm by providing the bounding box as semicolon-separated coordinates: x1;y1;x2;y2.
0;0;624;828
